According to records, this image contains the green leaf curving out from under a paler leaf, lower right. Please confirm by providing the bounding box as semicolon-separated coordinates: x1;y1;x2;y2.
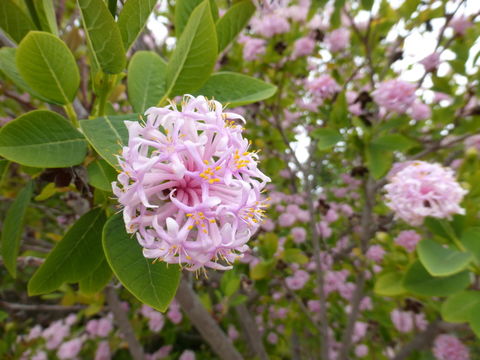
403;261;470;296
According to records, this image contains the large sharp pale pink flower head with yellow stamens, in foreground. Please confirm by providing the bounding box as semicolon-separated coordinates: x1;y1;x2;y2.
112;96;270;271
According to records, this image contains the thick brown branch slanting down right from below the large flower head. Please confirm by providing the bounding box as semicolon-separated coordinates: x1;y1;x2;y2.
175;278;243;360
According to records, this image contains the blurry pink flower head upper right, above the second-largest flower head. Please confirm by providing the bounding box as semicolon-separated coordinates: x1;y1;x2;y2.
372;79;416;114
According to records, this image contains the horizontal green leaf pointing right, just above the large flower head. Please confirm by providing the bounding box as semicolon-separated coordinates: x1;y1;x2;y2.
194;71;277;107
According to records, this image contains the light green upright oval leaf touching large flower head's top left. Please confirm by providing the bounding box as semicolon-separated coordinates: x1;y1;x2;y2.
127;51;167;114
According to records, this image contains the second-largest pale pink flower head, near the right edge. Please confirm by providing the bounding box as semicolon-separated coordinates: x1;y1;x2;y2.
385;161;467;226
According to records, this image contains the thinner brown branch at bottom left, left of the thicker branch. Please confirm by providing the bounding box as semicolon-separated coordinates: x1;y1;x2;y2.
105;286;145;360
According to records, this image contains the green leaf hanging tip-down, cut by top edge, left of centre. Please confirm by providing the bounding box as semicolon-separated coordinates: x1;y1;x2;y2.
78;0;126;74
